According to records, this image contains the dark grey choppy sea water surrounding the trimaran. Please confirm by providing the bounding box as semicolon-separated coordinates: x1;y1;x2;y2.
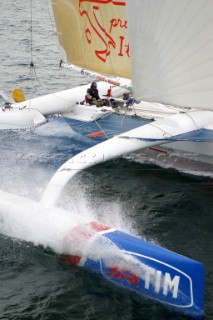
0;0;213;320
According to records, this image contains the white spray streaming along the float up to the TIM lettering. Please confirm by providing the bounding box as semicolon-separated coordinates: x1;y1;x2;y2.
0;191;175;300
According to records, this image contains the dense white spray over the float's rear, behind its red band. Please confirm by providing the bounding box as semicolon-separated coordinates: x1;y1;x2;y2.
0;191;87;253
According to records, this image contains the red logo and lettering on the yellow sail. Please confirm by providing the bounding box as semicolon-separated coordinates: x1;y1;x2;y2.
79;0;130;63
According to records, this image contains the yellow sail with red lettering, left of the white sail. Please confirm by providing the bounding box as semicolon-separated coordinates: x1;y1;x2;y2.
52;0;131;79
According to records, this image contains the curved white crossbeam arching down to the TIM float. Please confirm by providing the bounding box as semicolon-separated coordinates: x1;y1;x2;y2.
42;111;212;206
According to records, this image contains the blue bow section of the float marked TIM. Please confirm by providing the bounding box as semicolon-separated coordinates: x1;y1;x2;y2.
84;230;204;319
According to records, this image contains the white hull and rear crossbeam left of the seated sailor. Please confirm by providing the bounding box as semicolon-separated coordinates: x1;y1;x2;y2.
0;80;127;130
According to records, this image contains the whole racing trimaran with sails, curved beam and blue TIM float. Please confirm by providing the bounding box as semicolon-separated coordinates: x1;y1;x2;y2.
2;0;213;316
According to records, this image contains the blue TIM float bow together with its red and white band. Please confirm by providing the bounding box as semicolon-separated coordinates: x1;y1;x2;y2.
61;221;204;319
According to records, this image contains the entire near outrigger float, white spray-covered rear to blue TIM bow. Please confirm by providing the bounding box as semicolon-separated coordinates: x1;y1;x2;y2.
0;191;204;318
